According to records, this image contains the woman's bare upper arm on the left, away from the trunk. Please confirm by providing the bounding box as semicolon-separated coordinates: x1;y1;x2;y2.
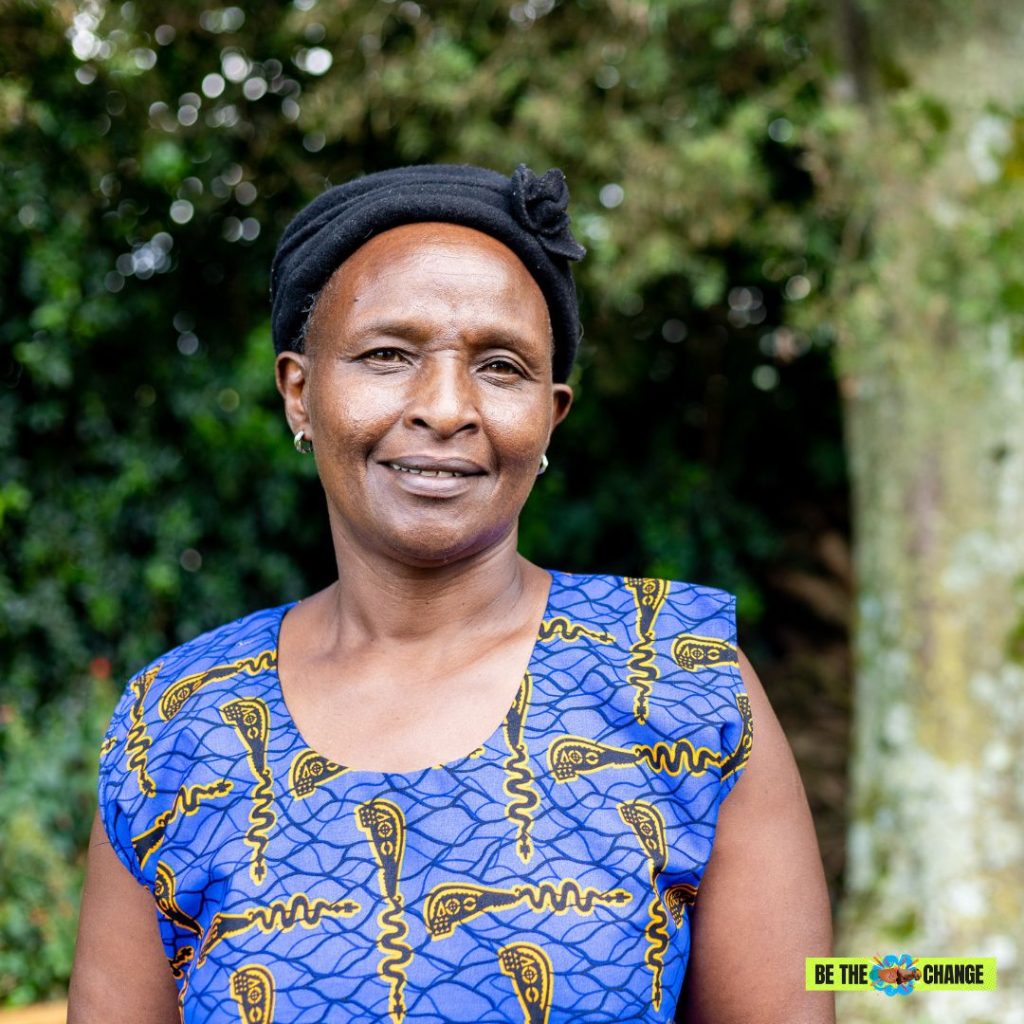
68;814;181;1024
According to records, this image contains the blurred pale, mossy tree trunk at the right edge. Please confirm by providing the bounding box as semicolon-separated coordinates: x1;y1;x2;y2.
835;3;1024;1022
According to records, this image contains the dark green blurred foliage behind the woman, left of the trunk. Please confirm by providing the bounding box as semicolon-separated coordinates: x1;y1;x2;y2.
0;0;849;1004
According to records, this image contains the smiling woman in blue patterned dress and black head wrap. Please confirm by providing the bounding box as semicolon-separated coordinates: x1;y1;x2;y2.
71;166;833;1024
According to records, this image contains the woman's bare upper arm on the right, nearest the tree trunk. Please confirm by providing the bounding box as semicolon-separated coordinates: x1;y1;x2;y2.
679;651;836;1024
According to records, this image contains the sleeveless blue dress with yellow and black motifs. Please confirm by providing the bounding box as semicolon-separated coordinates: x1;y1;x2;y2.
99;572;752;1024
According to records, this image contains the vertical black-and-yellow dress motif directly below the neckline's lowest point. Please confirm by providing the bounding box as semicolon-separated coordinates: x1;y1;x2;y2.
355;800;413;1024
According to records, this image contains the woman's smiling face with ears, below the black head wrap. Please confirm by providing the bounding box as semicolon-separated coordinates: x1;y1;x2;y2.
276;223;572;566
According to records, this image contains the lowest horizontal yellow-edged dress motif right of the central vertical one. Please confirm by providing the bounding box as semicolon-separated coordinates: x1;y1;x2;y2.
423;879;633;939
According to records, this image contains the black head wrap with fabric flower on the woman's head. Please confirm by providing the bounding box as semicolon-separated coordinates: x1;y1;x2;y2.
270;164;587;381
